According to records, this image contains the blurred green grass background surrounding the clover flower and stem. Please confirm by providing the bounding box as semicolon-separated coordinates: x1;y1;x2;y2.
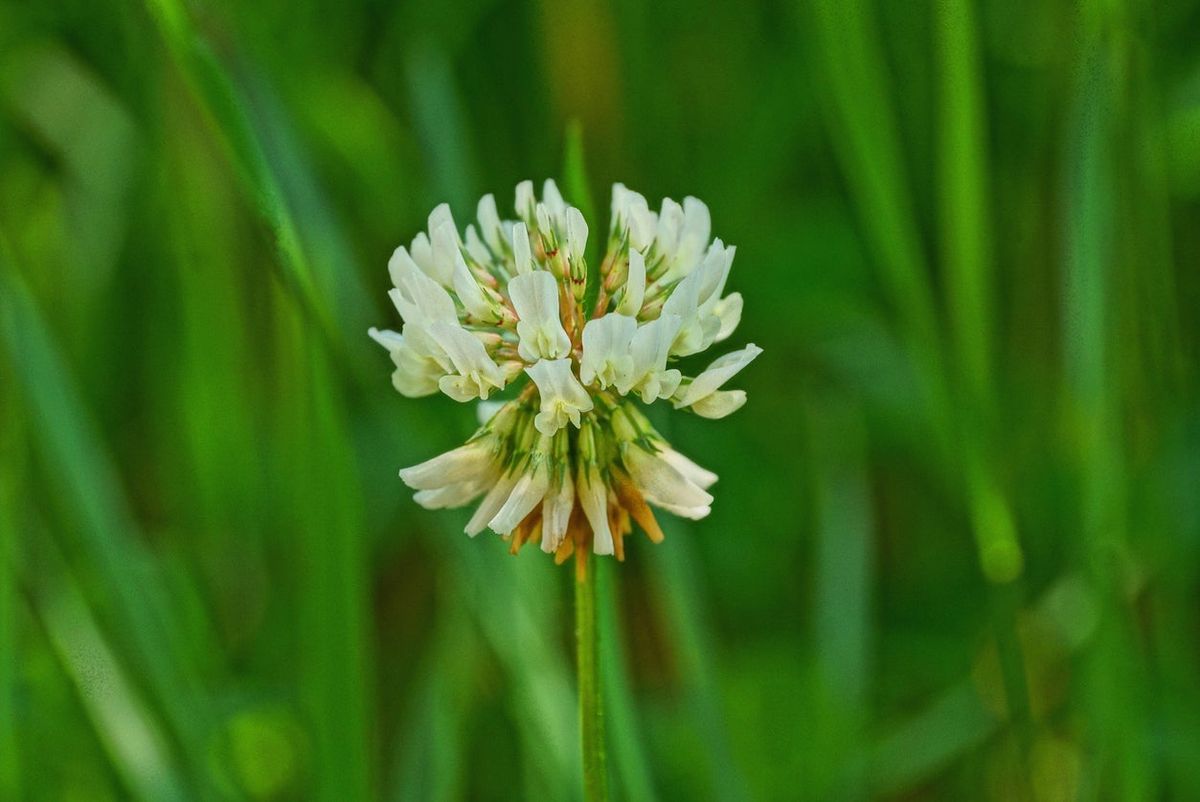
0;0;1200;802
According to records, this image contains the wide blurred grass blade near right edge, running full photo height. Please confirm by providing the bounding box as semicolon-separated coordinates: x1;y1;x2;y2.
1062;2;1160;800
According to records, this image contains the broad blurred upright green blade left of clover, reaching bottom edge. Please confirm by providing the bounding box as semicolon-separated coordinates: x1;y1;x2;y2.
276;307;374;801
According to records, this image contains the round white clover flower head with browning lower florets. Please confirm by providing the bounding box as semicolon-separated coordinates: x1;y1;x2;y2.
370;180;762;571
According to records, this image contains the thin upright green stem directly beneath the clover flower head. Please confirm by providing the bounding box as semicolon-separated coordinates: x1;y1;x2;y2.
575;565;608;802
